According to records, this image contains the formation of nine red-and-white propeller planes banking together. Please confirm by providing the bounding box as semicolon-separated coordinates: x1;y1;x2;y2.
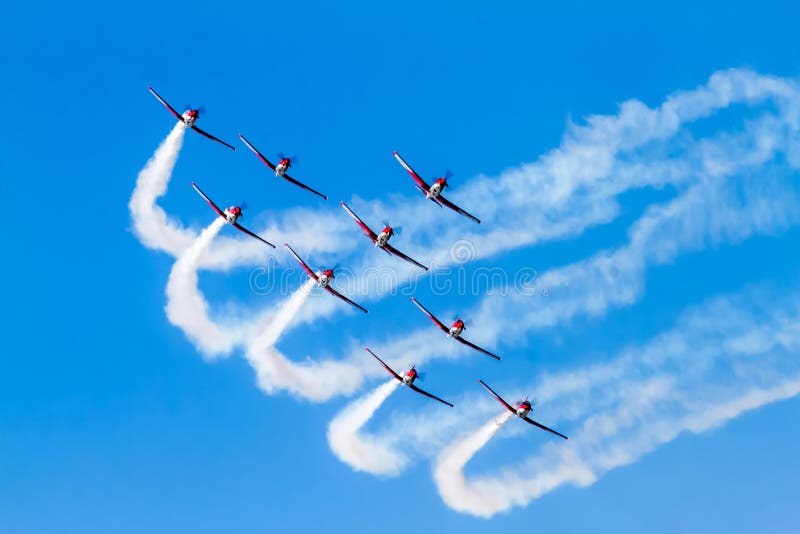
147;87;568;439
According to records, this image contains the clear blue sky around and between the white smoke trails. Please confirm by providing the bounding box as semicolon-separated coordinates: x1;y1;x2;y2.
0;0;800;534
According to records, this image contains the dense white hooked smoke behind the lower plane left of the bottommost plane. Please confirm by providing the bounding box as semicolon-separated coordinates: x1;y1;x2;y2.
328;379;405;476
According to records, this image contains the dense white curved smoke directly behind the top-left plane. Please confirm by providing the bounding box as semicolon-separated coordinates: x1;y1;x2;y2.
128;122;195;258
